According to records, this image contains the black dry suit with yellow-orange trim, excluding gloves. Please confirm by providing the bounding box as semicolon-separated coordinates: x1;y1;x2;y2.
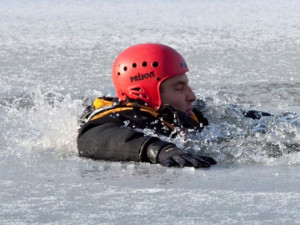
77;97;208;163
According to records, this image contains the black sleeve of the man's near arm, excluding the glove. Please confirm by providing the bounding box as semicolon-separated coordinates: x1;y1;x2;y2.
77;123;171;162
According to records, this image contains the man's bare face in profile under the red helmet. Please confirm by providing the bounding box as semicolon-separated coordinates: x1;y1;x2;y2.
160;74;196;114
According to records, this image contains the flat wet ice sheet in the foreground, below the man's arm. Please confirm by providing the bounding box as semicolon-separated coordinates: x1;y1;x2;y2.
1;155;300;224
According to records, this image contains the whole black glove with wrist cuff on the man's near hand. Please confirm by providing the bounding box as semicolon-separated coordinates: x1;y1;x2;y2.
147;142;217;168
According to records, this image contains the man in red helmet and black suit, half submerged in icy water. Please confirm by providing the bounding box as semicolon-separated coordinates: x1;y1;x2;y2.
77;43;216;168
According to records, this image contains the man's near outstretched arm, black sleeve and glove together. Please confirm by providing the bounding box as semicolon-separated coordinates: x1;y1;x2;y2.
77;123;216;168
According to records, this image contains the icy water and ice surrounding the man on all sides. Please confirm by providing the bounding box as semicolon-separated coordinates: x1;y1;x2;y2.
0;0;300;225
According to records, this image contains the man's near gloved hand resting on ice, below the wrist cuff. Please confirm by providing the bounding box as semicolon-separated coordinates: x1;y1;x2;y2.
158;146;217;168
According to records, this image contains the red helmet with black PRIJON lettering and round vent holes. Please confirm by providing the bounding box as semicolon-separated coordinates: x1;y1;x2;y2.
112;43;189;109
